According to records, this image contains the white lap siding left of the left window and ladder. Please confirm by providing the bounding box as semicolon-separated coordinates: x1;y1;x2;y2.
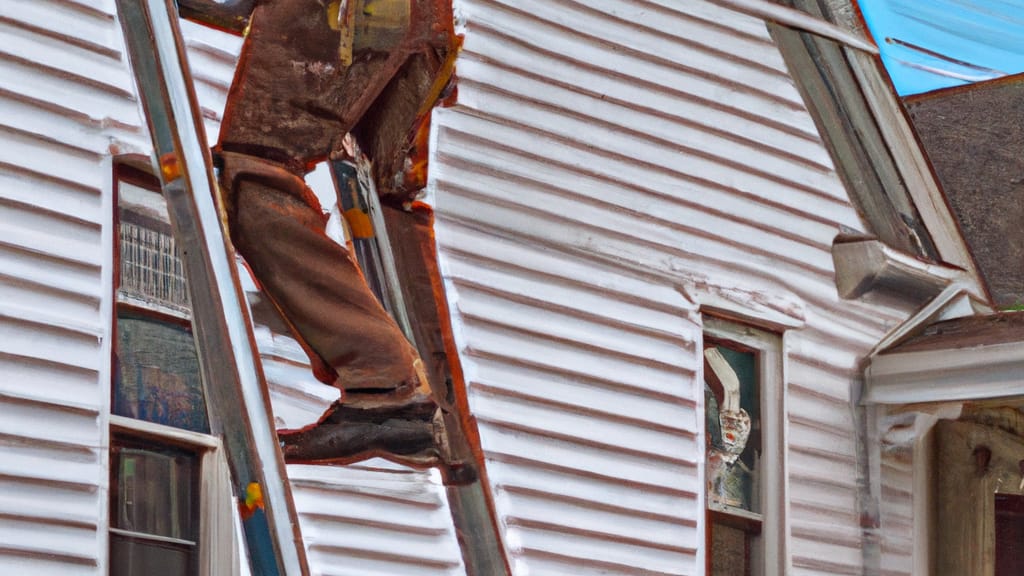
0;0;135;575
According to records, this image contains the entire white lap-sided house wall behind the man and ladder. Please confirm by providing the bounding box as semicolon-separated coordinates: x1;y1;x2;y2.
0;0;946;575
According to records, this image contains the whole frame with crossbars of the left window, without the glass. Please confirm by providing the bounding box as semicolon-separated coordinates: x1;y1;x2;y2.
103;156;242;576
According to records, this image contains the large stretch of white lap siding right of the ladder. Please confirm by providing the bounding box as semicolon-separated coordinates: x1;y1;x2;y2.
430;0;905;574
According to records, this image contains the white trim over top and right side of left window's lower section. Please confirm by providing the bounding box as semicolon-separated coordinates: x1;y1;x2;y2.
108;414;241;576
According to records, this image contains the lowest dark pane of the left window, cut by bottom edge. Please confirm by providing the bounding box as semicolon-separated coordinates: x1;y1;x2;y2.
110;534;196;576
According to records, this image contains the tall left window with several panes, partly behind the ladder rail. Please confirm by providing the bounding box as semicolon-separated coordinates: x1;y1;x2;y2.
109;165;238;576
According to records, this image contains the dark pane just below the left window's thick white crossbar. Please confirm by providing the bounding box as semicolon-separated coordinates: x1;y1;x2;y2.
111;446;199;541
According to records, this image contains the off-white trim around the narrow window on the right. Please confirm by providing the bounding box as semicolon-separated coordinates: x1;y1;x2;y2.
696;316;791;576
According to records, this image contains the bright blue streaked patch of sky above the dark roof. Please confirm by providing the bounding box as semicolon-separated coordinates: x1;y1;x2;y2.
859;0;1024;95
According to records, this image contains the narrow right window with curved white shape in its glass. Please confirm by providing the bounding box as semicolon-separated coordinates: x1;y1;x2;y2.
701;318;787;576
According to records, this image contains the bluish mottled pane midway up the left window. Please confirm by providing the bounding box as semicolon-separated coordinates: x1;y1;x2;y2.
114;316;210;433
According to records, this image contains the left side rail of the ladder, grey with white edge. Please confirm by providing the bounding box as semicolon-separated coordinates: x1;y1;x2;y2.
117;0;309;576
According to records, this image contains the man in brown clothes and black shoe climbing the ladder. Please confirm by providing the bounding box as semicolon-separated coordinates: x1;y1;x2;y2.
179;0;454;470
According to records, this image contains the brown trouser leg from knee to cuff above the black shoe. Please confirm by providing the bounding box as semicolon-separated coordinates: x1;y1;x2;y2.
220;152;426;397
